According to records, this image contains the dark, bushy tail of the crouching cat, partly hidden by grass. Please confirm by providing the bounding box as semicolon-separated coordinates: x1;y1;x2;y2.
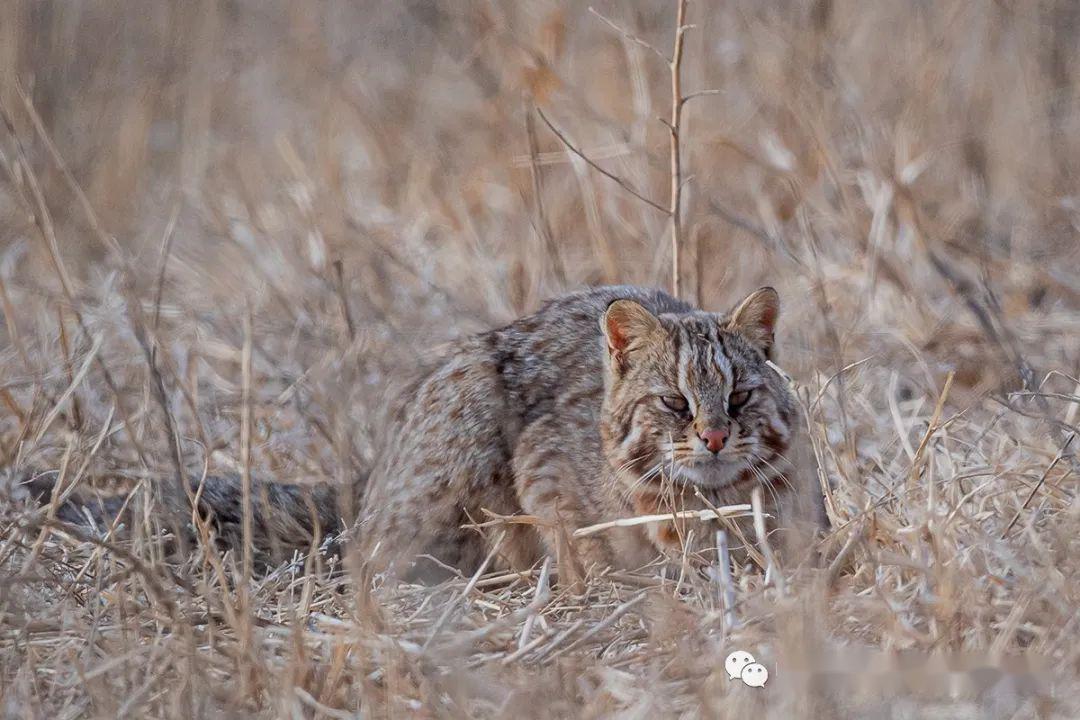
13;472;348;568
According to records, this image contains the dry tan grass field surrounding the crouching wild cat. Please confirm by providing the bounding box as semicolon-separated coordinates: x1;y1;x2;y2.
0;0;1080;718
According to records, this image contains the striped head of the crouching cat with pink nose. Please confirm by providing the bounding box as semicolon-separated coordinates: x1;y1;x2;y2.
600;287;797;488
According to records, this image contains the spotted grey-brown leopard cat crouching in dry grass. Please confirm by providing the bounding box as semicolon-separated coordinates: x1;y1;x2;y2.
21;286;814;578
